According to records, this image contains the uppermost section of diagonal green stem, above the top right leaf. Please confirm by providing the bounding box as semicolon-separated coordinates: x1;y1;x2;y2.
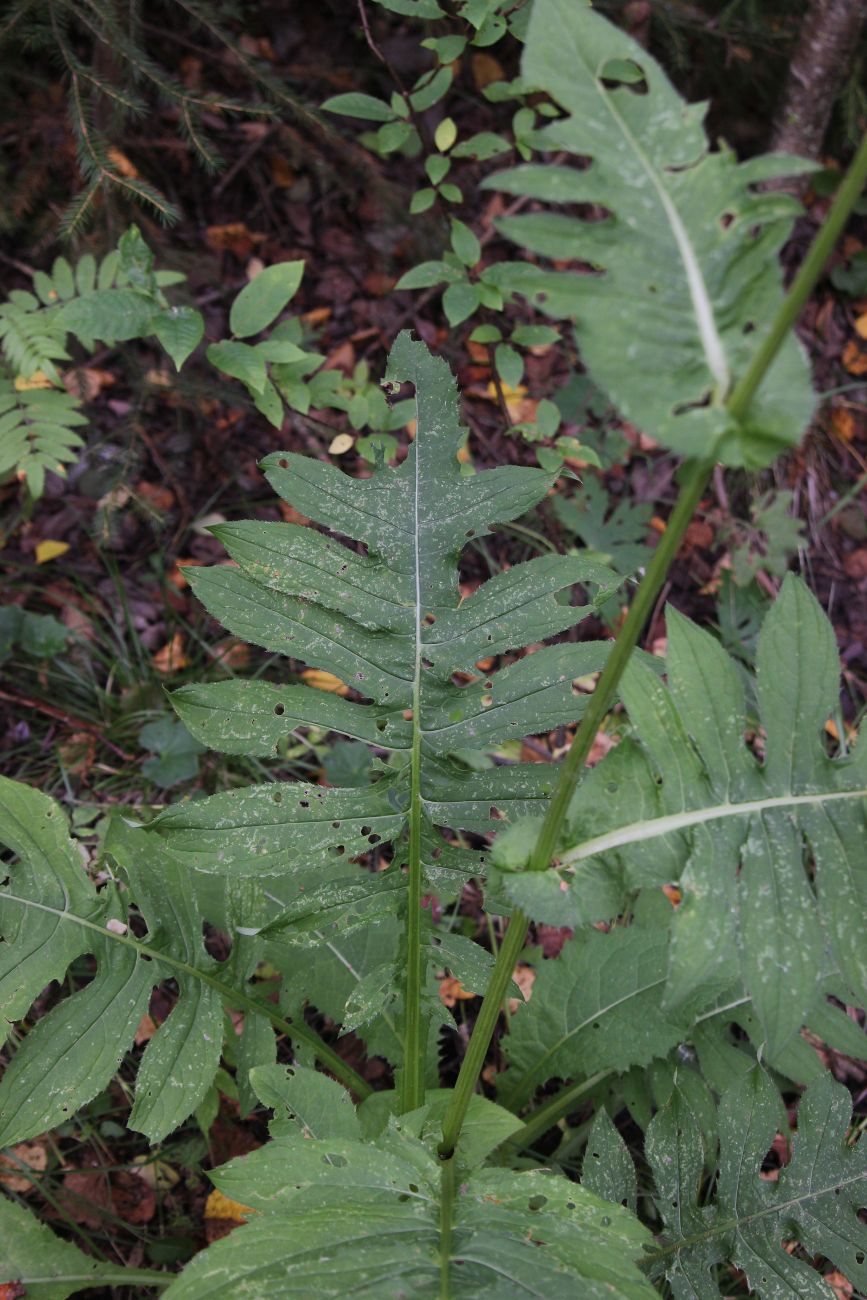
725;134;867;420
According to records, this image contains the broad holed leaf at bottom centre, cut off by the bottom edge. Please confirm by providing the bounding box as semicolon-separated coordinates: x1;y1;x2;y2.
166;1069;654;1300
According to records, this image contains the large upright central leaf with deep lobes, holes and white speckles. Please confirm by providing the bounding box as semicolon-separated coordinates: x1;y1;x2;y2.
155;334;620;1055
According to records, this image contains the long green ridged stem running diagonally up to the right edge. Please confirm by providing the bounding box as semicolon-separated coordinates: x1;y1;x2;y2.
439;126;867;1160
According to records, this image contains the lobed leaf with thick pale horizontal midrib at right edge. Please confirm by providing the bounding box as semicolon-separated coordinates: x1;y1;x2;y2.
495;576;867;1076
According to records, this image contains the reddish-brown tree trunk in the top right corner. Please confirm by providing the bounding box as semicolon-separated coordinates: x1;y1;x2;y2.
772;0;867;159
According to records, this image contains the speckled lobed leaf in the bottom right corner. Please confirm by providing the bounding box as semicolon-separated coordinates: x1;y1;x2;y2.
646;1067;867;1300
